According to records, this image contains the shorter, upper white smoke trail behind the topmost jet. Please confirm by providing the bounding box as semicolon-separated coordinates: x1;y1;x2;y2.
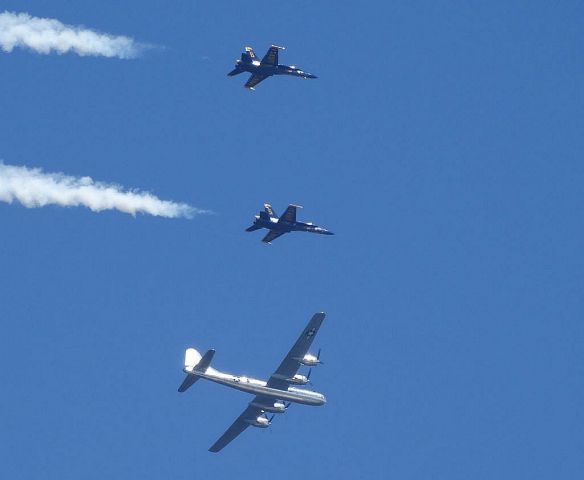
0;11;144;58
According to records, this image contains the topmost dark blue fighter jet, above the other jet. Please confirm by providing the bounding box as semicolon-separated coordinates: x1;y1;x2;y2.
227;45;316;90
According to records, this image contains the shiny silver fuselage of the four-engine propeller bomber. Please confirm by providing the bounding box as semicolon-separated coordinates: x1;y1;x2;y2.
183;367;326;406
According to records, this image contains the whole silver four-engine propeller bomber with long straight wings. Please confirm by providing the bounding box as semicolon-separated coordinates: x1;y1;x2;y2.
178;313;326;452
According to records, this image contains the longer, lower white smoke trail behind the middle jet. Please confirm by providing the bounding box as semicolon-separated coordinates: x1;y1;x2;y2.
0;161;198;218
